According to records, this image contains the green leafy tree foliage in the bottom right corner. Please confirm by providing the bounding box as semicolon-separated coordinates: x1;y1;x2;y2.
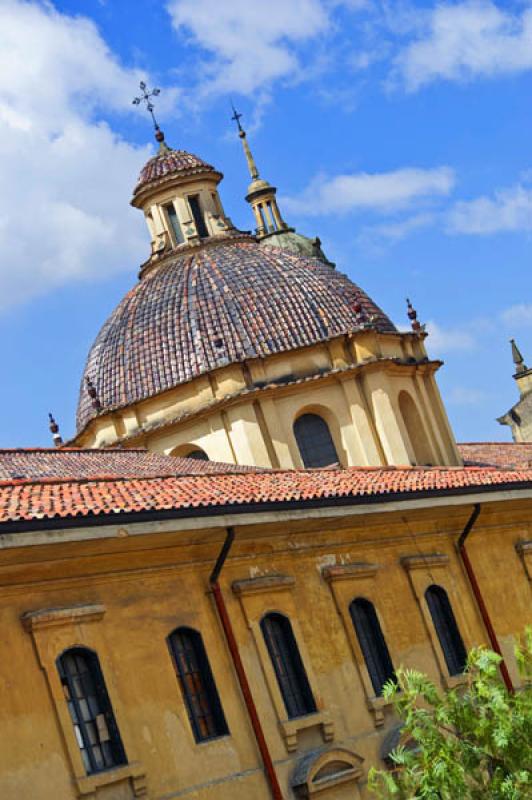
369;629;532;800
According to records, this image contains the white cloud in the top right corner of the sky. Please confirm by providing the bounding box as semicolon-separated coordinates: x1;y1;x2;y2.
395;0;532;90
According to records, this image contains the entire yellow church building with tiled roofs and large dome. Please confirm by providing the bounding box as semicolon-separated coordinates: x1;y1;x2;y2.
0;116;532;800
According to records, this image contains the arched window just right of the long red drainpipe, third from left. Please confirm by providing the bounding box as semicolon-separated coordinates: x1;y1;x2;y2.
260;612;316;719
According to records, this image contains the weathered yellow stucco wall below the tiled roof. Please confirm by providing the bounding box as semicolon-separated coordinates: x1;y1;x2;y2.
0;500;532;800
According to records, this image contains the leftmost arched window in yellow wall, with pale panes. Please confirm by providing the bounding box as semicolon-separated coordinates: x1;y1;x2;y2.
57;647;127;774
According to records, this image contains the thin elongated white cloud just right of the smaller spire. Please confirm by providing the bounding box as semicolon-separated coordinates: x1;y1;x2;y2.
282;167;455;216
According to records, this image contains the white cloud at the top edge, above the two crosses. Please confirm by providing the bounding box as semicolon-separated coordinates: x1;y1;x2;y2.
167;0;329;94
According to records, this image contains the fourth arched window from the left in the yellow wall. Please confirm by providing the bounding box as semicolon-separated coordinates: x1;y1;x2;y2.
349;597;395;695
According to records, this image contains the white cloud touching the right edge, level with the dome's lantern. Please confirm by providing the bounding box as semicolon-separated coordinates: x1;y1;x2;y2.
447;180;532;235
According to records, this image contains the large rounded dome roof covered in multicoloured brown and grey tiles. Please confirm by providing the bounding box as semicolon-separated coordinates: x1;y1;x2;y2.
77;236;395;432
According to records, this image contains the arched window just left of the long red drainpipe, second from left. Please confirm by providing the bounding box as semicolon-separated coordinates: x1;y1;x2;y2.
168;628;229;742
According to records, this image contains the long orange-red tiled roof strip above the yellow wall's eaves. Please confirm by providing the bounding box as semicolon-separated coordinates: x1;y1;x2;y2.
0;467;532;524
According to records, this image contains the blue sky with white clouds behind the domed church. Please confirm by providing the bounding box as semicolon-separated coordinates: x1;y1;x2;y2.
0;0;532;446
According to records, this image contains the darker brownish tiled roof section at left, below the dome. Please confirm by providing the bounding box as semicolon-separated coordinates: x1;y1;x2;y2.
0;448;254;480
